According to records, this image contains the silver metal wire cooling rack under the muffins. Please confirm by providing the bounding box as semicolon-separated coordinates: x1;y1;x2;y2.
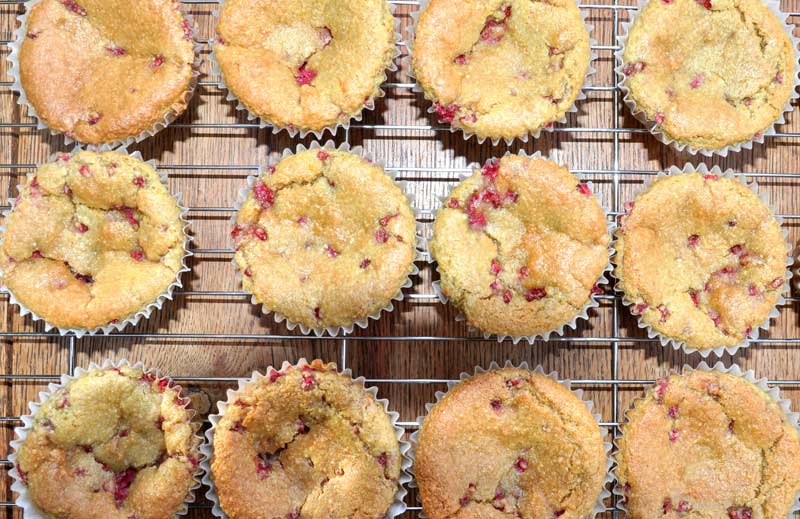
0;0;800;519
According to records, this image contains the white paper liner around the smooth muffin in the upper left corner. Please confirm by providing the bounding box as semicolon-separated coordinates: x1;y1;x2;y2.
7;0;202;151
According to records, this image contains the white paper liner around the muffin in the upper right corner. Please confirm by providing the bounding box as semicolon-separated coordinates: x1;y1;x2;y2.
614;0;800;157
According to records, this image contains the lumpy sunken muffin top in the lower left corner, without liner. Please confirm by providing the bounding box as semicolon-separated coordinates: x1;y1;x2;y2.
17;366;200;519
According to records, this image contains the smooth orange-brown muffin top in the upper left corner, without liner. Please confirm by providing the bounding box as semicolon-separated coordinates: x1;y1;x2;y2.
19;0;194;144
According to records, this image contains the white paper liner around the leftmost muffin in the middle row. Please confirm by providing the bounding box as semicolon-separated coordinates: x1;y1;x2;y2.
0;146;194;338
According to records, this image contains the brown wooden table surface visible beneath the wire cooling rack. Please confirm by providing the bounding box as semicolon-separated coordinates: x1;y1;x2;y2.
0;0;800;518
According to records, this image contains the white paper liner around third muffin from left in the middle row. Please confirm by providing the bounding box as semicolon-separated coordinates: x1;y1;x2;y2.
422;150;614;344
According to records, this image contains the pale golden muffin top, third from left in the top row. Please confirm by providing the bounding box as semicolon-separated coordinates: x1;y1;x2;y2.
412;0;590;139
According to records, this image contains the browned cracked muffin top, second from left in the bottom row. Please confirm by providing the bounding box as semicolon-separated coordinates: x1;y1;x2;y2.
211;360;402;519
